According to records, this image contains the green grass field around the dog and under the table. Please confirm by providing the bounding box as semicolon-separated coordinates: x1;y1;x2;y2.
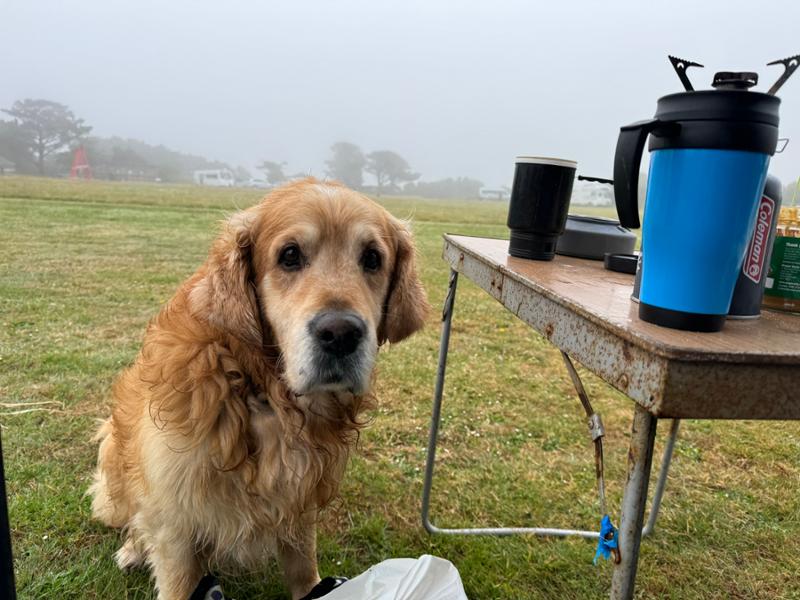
0;178;800;600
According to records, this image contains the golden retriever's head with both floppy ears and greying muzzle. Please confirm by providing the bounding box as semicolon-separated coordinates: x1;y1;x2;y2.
190;179;428;395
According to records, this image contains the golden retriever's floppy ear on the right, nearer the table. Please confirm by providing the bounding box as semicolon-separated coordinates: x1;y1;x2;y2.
378;219;430;344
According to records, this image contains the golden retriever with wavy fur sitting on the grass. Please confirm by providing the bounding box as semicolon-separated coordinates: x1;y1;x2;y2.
89;179;429;600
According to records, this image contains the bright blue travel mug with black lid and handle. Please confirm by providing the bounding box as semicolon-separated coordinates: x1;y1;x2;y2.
614;73;780;331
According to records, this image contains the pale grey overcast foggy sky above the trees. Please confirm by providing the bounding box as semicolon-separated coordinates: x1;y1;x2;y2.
0;0;800;187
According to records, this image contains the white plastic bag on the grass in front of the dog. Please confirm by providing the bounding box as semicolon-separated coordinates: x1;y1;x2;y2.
325;554;467;600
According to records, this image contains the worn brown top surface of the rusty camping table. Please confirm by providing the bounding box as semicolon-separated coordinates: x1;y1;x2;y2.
444;234;800;366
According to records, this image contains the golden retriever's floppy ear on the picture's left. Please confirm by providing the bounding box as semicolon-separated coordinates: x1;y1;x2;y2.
189;210;264;346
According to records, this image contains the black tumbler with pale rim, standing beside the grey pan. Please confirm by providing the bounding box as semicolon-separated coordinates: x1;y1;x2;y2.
508;156;578;260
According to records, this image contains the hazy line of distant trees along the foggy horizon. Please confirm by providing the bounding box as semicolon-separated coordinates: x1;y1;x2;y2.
0;98;494;198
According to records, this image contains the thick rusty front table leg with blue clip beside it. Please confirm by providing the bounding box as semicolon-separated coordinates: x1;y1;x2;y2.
611;404;658;600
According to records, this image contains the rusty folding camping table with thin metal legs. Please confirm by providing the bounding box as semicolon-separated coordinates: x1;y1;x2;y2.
422;234;800;600
